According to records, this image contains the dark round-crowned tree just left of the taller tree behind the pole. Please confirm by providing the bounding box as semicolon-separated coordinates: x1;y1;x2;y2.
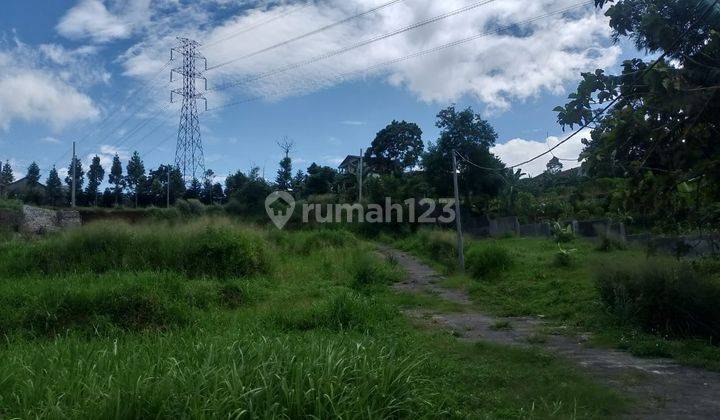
365;120;423;174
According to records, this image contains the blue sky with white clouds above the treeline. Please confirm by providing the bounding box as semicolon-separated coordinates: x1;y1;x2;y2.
0;0;641;185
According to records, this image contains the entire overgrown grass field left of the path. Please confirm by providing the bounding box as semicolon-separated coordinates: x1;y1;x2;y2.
0;220;625;418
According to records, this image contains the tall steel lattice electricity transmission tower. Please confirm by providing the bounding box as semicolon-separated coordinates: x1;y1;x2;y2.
170;38;207;182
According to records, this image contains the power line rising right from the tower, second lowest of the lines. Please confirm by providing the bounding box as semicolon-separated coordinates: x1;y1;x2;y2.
209;0;496;91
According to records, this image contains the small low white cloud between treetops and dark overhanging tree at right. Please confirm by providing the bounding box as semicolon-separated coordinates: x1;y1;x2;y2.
490;129;590;176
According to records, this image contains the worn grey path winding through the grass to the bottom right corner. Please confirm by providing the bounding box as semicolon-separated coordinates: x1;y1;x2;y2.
380;247;720;419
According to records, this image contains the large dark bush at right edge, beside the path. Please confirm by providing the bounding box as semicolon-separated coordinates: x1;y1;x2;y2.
595;259;720;339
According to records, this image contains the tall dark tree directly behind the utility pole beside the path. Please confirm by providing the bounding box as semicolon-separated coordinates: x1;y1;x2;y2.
423;106;504;201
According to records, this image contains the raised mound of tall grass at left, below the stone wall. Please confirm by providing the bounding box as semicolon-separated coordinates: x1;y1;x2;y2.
0;221;270;277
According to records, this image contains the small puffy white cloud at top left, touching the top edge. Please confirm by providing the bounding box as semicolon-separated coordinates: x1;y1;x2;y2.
57;0;132;43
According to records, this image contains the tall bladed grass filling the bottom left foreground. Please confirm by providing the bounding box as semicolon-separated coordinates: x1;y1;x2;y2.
0;331;440;419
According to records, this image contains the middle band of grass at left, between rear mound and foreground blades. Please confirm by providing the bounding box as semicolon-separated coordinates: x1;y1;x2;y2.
0;273;247;337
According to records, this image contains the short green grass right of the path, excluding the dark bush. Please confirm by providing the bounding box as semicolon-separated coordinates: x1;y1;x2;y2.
385;231;720;370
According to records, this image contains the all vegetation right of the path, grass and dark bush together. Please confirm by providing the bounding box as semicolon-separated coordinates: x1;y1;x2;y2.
386;231;720;370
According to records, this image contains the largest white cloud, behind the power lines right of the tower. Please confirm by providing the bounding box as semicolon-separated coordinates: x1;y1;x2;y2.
167;0;620;111
